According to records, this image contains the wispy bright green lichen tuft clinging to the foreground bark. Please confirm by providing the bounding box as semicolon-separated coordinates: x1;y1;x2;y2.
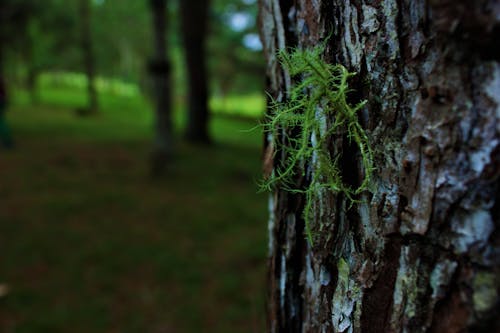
262;46;373;243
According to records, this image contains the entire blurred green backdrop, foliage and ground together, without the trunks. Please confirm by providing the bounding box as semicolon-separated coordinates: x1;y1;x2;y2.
0;0;267;333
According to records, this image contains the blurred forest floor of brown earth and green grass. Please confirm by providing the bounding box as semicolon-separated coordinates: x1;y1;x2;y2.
0;91;267;333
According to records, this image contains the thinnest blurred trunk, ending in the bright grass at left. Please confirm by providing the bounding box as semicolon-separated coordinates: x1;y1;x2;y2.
80;0;98;114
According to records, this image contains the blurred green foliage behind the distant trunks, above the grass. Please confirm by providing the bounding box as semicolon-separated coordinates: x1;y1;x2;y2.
0;0;264;123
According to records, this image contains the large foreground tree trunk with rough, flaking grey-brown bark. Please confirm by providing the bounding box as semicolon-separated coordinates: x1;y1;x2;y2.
260;0;500;333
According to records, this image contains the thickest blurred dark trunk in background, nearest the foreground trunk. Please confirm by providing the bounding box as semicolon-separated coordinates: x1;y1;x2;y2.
180;0;210;143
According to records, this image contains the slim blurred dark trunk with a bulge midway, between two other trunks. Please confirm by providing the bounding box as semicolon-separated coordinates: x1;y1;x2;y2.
149;0;173;175
